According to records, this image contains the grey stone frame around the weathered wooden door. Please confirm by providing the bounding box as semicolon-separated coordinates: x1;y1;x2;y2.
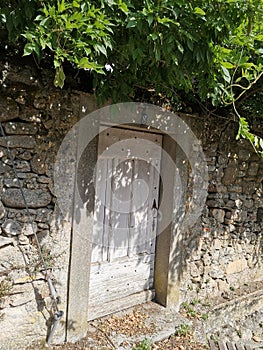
66;122;183;342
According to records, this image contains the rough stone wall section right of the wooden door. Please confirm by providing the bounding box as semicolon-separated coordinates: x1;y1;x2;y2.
181;117;263;300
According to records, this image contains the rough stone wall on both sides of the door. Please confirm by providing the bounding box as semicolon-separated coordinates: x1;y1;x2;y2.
0;60;263;349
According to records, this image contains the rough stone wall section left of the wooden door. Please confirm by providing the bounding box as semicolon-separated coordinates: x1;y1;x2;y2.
0;60;96;349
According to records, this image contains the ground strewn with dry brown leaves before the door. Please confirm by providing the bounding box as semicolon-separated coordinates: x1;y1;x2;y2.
50;309;207;350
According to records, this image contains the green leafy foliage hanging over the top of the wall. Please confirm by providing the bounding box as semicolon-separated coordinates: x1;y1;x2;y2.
0;0;263;156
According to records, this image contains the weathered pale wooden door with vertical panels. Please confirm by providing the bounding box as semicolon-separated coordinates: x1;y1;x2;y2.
88;128;162;320
